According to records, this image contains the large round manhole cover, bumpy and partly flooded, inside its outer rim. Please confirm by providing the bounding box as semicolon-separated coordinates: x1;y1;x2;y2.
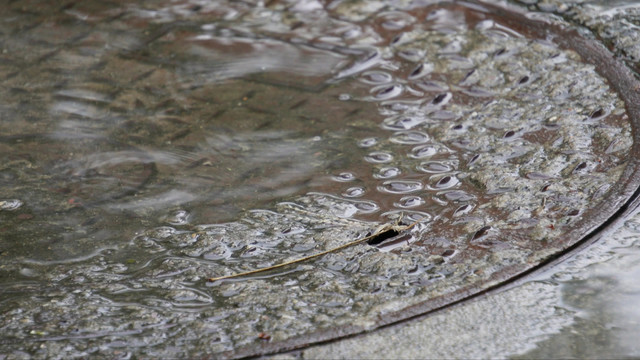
0;2;638;357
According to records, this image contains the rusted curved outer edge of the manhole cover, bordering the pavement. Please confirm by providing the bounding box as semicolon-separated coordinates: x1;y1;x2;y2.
221;1;640;359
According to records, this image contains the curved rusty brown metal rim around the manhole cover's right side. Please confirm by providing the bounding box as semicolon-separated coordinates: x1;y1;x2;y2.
221;1;640;357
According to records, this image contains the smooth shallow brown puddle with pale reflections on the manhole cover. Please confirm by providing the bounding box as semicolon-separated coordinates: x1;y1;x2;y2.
0;8;376;260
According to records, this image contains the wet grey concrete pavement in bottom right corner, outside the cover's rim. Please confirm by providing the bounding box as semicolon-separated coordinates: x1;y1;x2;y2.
296;210;640;359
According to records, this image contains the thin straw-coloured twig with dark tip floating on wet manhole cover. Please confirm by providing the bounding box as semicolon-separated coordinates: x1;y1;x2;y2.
209;215;420;282
